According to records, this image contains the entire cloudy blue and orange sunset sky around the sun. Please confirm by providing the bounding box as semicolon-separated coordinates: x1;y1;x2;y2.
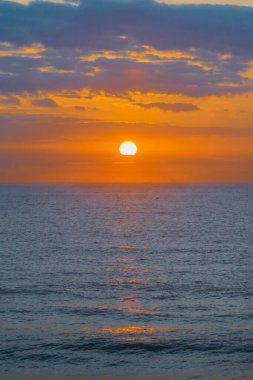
0;0;253;182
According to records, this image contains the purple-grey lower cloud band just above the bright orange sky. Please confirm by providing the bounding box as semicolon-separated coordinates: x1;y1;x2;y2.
0;50;252;97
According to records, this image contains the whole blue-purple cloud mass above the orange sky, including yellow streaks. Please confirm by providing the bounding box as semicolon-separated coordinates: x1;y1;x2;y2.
0;0;253;96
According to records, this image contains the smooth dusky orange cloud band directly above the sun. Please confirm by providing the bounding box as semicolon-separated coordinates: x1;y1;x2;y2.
0;115;253;147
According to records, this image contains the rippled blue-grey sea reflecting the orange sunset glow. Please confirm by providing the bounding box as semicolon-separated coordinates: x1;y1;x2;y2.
0;184;253;380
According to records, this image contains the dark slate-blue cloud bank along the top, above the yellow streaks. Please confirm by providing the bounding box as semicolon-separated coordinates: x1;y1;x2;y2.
0;0;253;56
